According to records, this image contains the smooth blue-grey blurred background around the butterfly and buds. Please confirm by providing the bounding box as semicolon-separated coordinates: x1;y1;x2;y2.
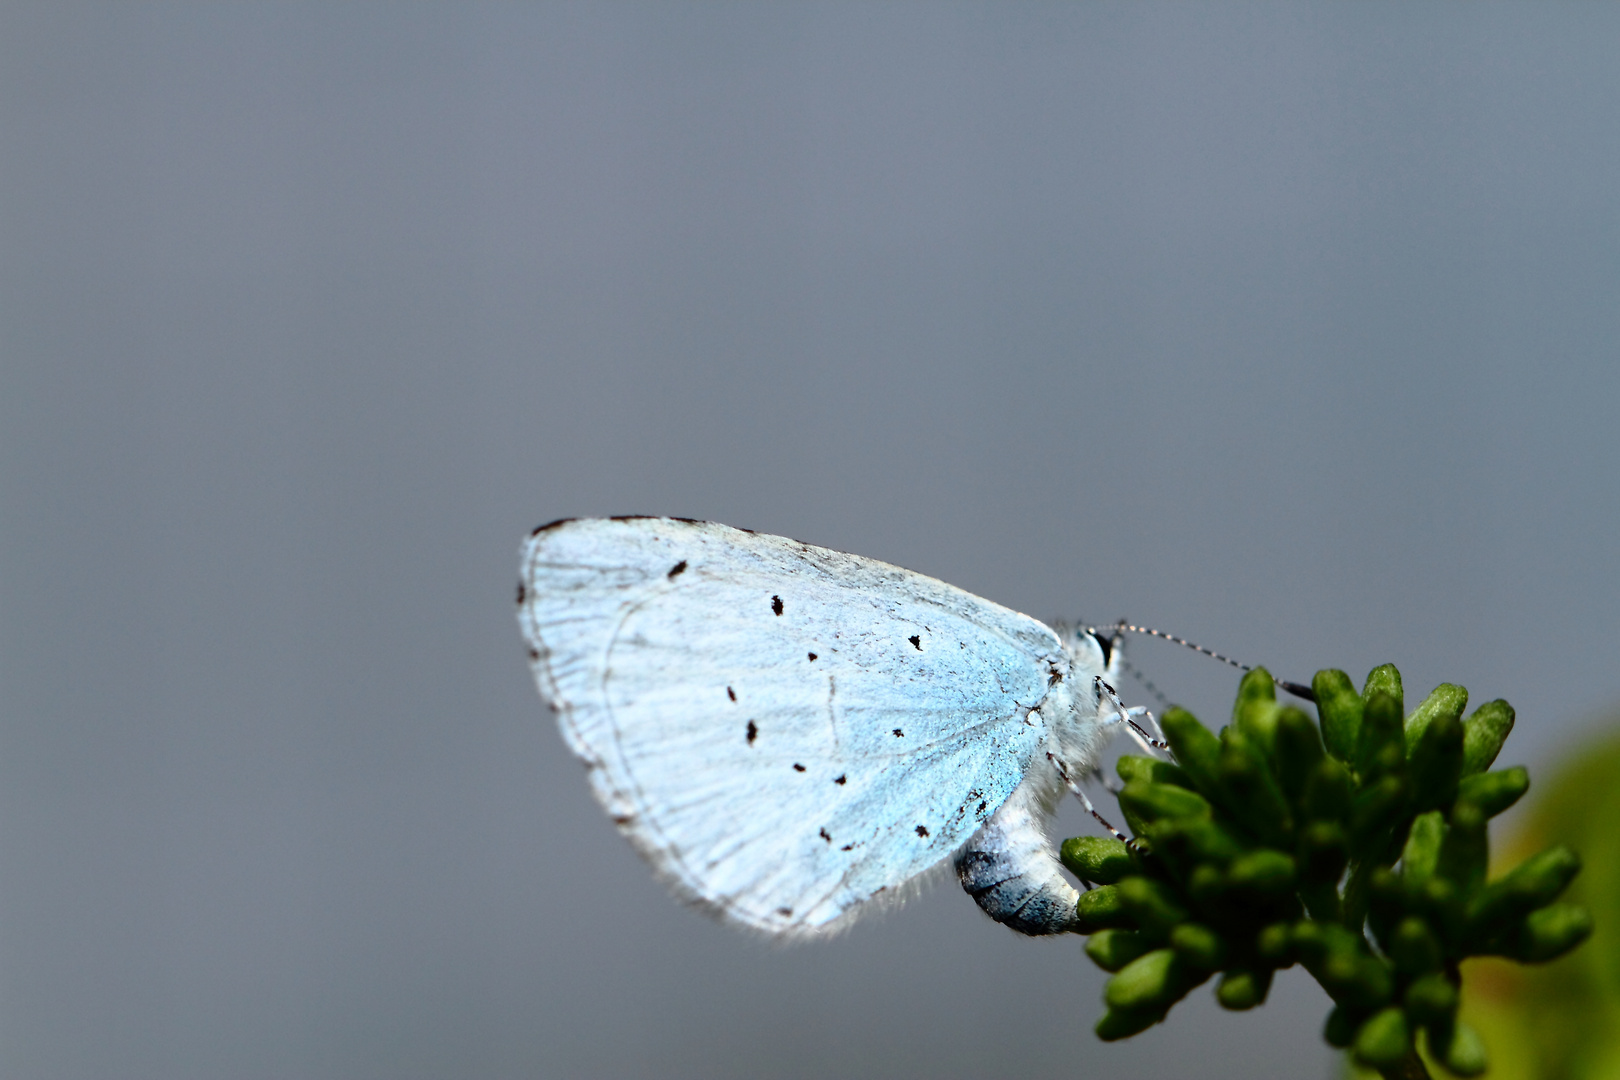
0;3;1620;1078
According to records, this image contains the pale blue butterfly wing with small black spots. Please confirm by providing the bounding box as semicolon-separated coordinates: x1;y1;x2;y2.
520;518;1069;934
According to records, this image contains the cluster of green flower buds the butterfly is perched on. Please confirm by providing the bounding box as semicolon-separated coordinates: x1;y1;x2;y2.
1061;664;1591;1077
